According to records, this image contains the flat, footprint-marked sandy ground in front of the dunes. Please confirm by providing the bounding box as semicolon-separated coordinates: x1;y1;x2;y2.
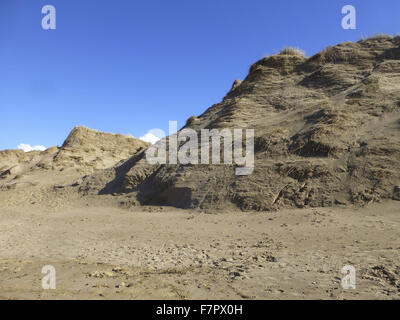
0;196;400;299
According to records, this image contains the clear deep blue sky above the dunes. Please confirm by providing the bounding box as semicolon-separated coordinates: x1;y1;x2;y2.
0;0;400;149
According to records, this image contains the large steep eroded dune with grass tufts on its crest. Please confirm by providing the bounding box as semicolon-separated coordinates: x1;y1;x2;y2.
79;37;400;210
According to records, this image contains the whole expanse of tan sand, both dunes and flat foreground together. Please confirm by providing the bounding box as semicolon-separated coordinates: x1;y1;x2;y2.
0;36;400;299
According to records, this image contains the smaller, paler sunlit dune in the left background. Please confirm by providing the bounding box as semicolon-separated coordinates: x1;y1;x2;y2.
0;127;148;189
